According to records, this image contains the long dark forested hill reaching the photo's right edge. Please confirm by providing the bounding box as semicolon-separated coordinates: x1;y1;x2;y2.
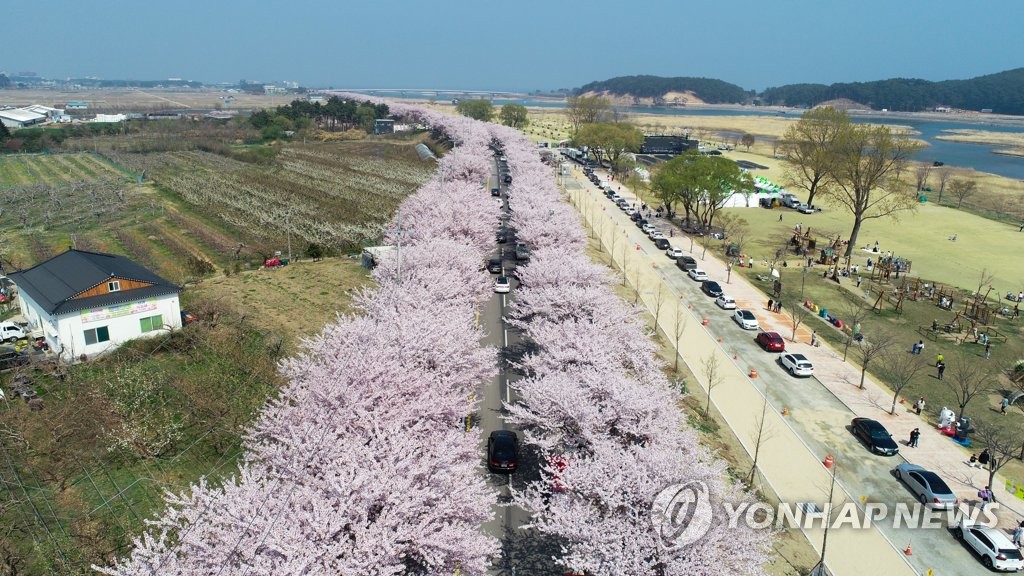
761;68;1024;115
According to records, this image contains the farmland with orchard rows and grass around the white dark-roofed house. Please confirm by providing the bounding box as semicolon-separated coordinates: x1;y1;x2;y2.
0;133;433;574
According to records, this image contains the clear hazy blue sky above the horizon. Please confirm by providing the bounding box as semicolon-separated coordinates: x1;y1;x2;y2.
0;0;1024;91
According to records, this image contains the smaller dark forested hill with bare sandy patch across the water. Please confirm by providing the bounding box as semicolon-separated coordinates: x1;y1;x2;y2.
577;76;754;104
